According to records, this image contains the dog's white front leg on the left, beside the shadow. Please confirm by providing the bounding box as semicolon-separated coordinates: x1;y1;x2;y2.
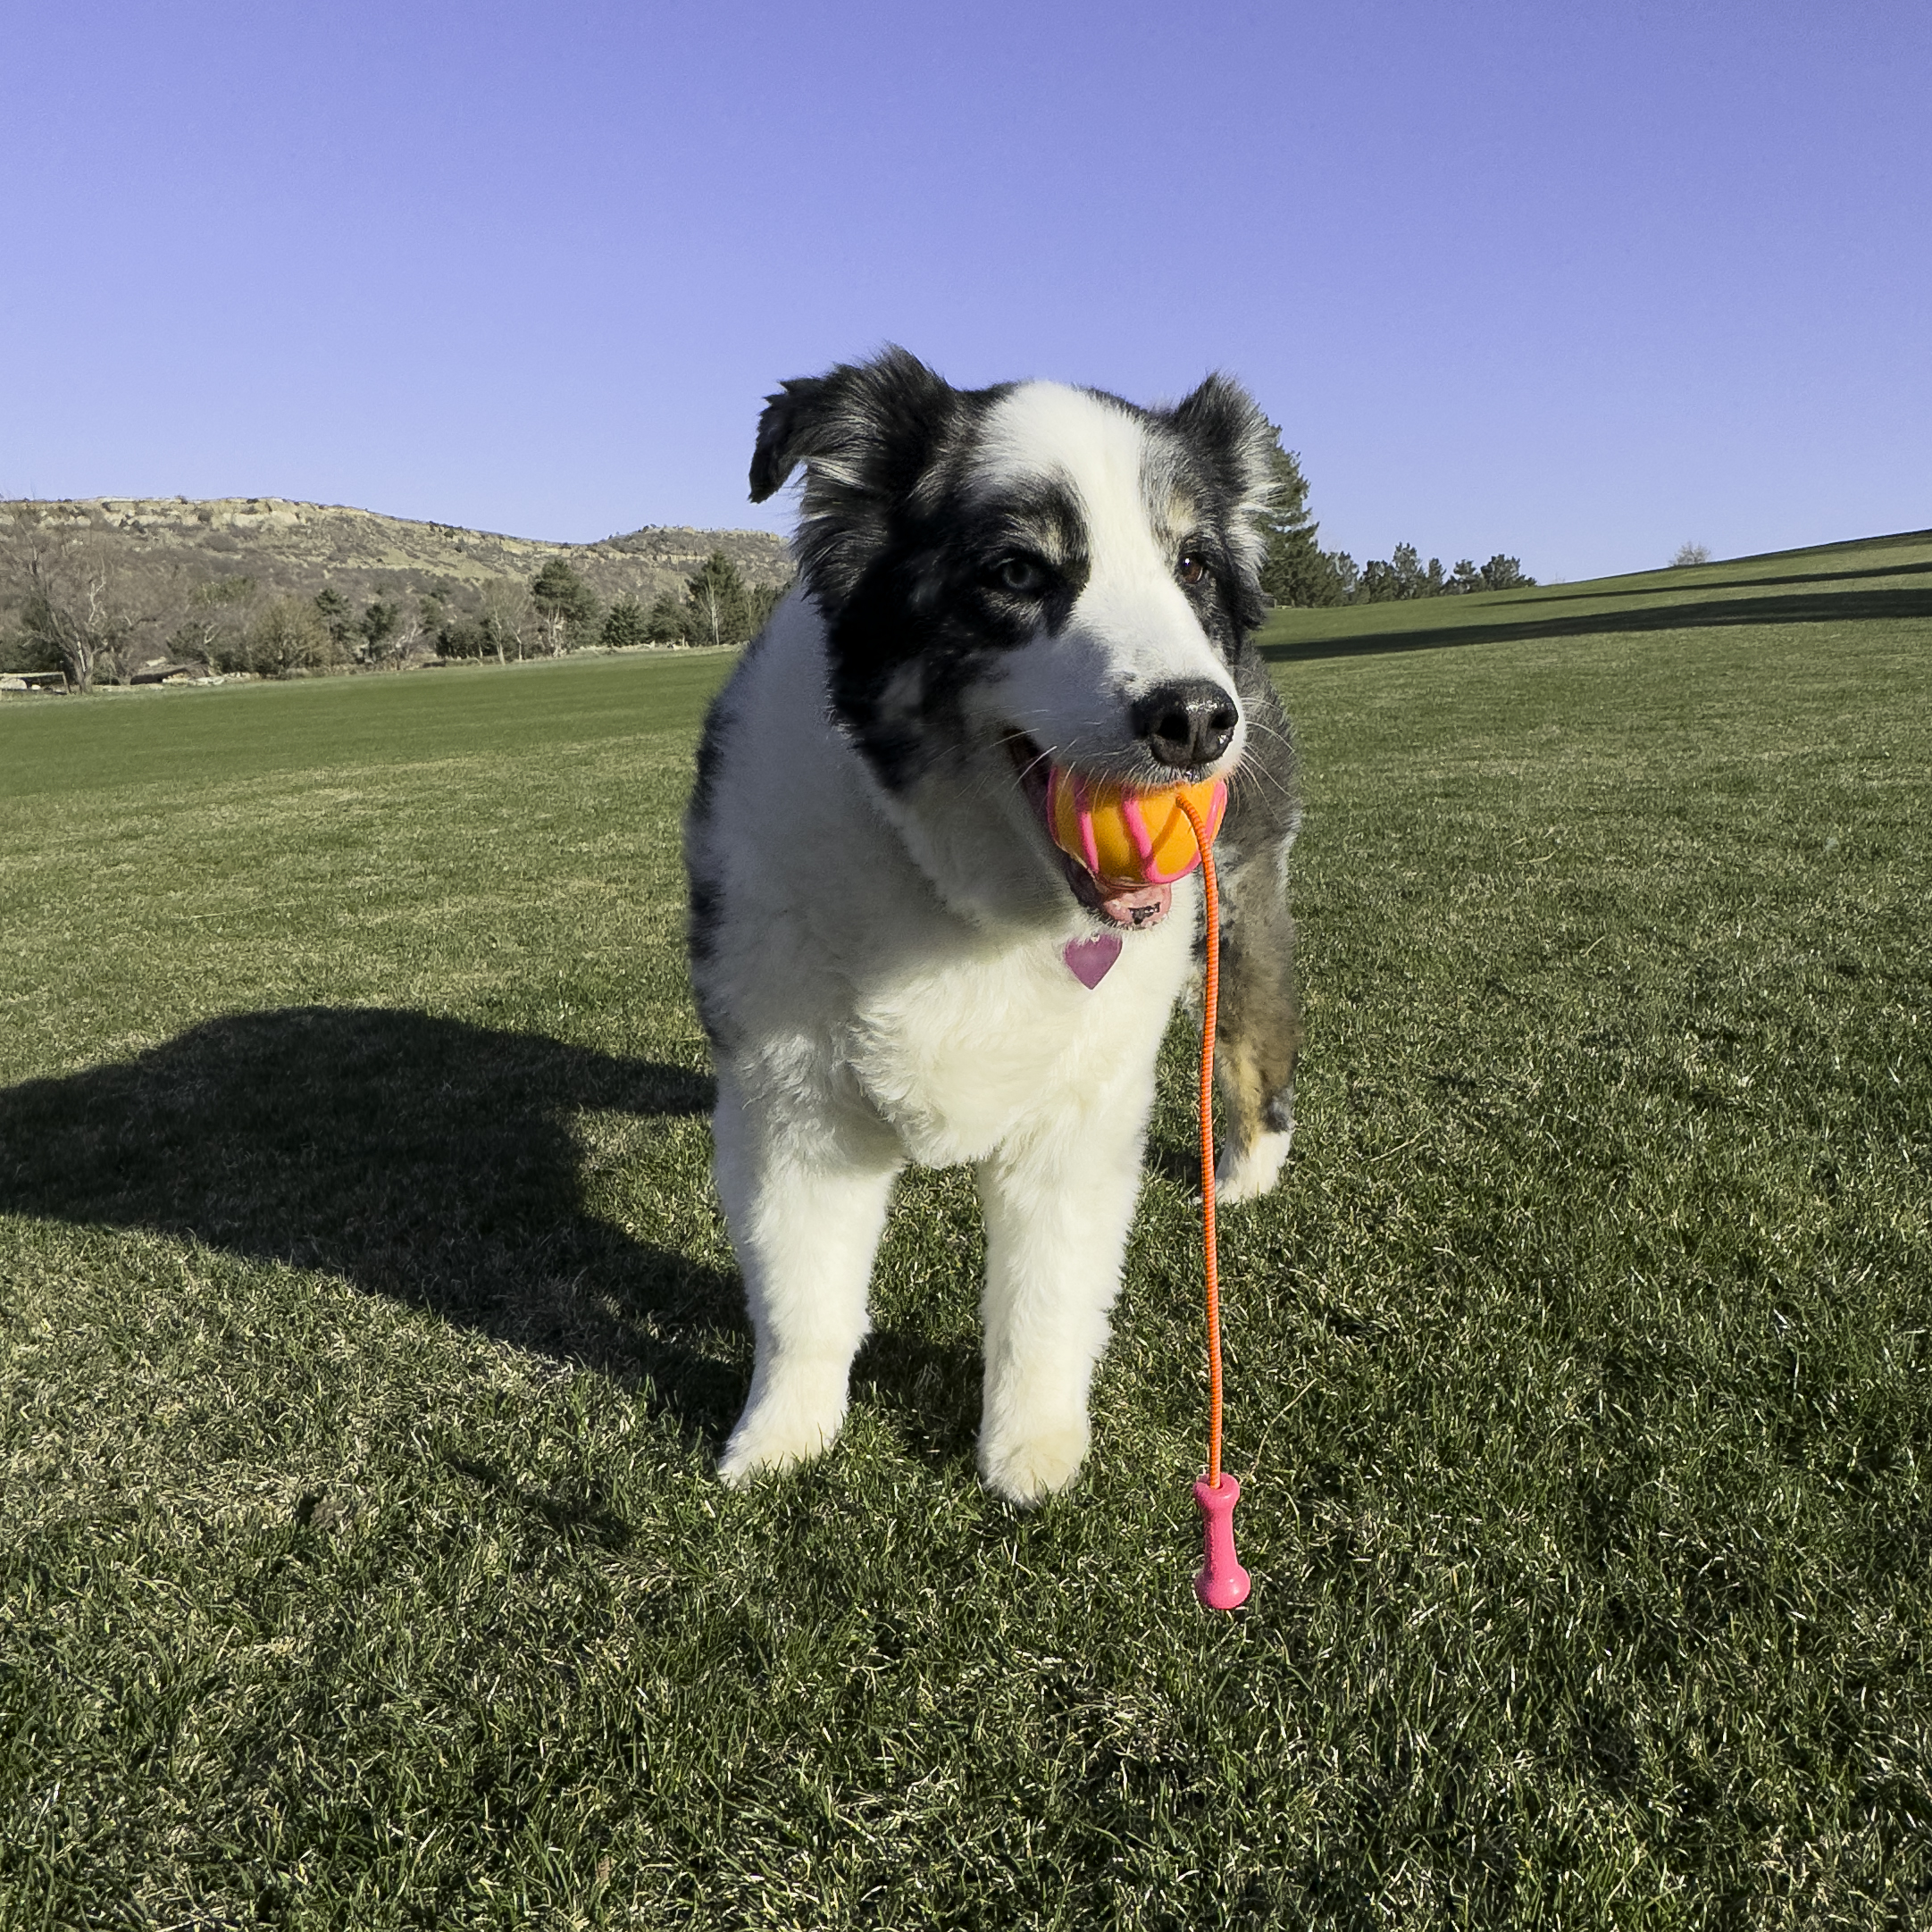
715;1076;900;1488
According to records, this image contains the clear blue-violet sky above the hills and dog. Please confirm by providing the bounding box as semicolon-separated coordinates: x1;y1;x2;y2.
0;0;1932;578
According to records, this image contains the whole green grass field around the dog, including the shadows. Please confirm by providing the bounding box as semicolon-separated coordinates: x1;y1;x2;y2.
0;535;1932;1932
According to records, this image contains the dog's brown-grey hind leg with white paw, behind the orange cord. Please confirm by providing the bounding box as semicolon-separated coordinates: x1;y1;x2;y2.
1216;854;1302;1204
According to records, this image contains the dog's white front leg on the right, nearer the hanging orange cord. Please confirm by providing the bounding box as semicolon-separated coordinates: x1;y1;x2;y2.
980;1098;1146;1503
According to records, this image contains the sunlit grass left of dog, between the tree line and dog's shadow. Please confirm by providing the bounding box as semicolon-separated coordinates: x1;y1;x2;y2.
0;653;731;1075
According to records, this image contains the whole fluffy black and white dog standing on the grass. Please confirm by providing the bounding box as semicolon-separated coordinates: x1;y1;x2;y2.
684;350;1296;1503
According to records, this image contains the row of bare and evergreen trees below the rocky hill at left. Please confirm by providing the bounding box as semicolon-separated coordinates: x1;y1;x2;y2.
0;512;786;691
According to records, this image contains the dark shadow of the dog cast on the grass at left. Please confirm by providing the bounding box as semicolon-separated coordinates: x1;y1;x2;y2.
0;1007;748;1447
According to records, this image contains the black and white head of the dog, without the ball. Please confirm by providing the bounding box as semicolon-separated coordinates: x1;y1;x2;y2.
751;347;1275;924
